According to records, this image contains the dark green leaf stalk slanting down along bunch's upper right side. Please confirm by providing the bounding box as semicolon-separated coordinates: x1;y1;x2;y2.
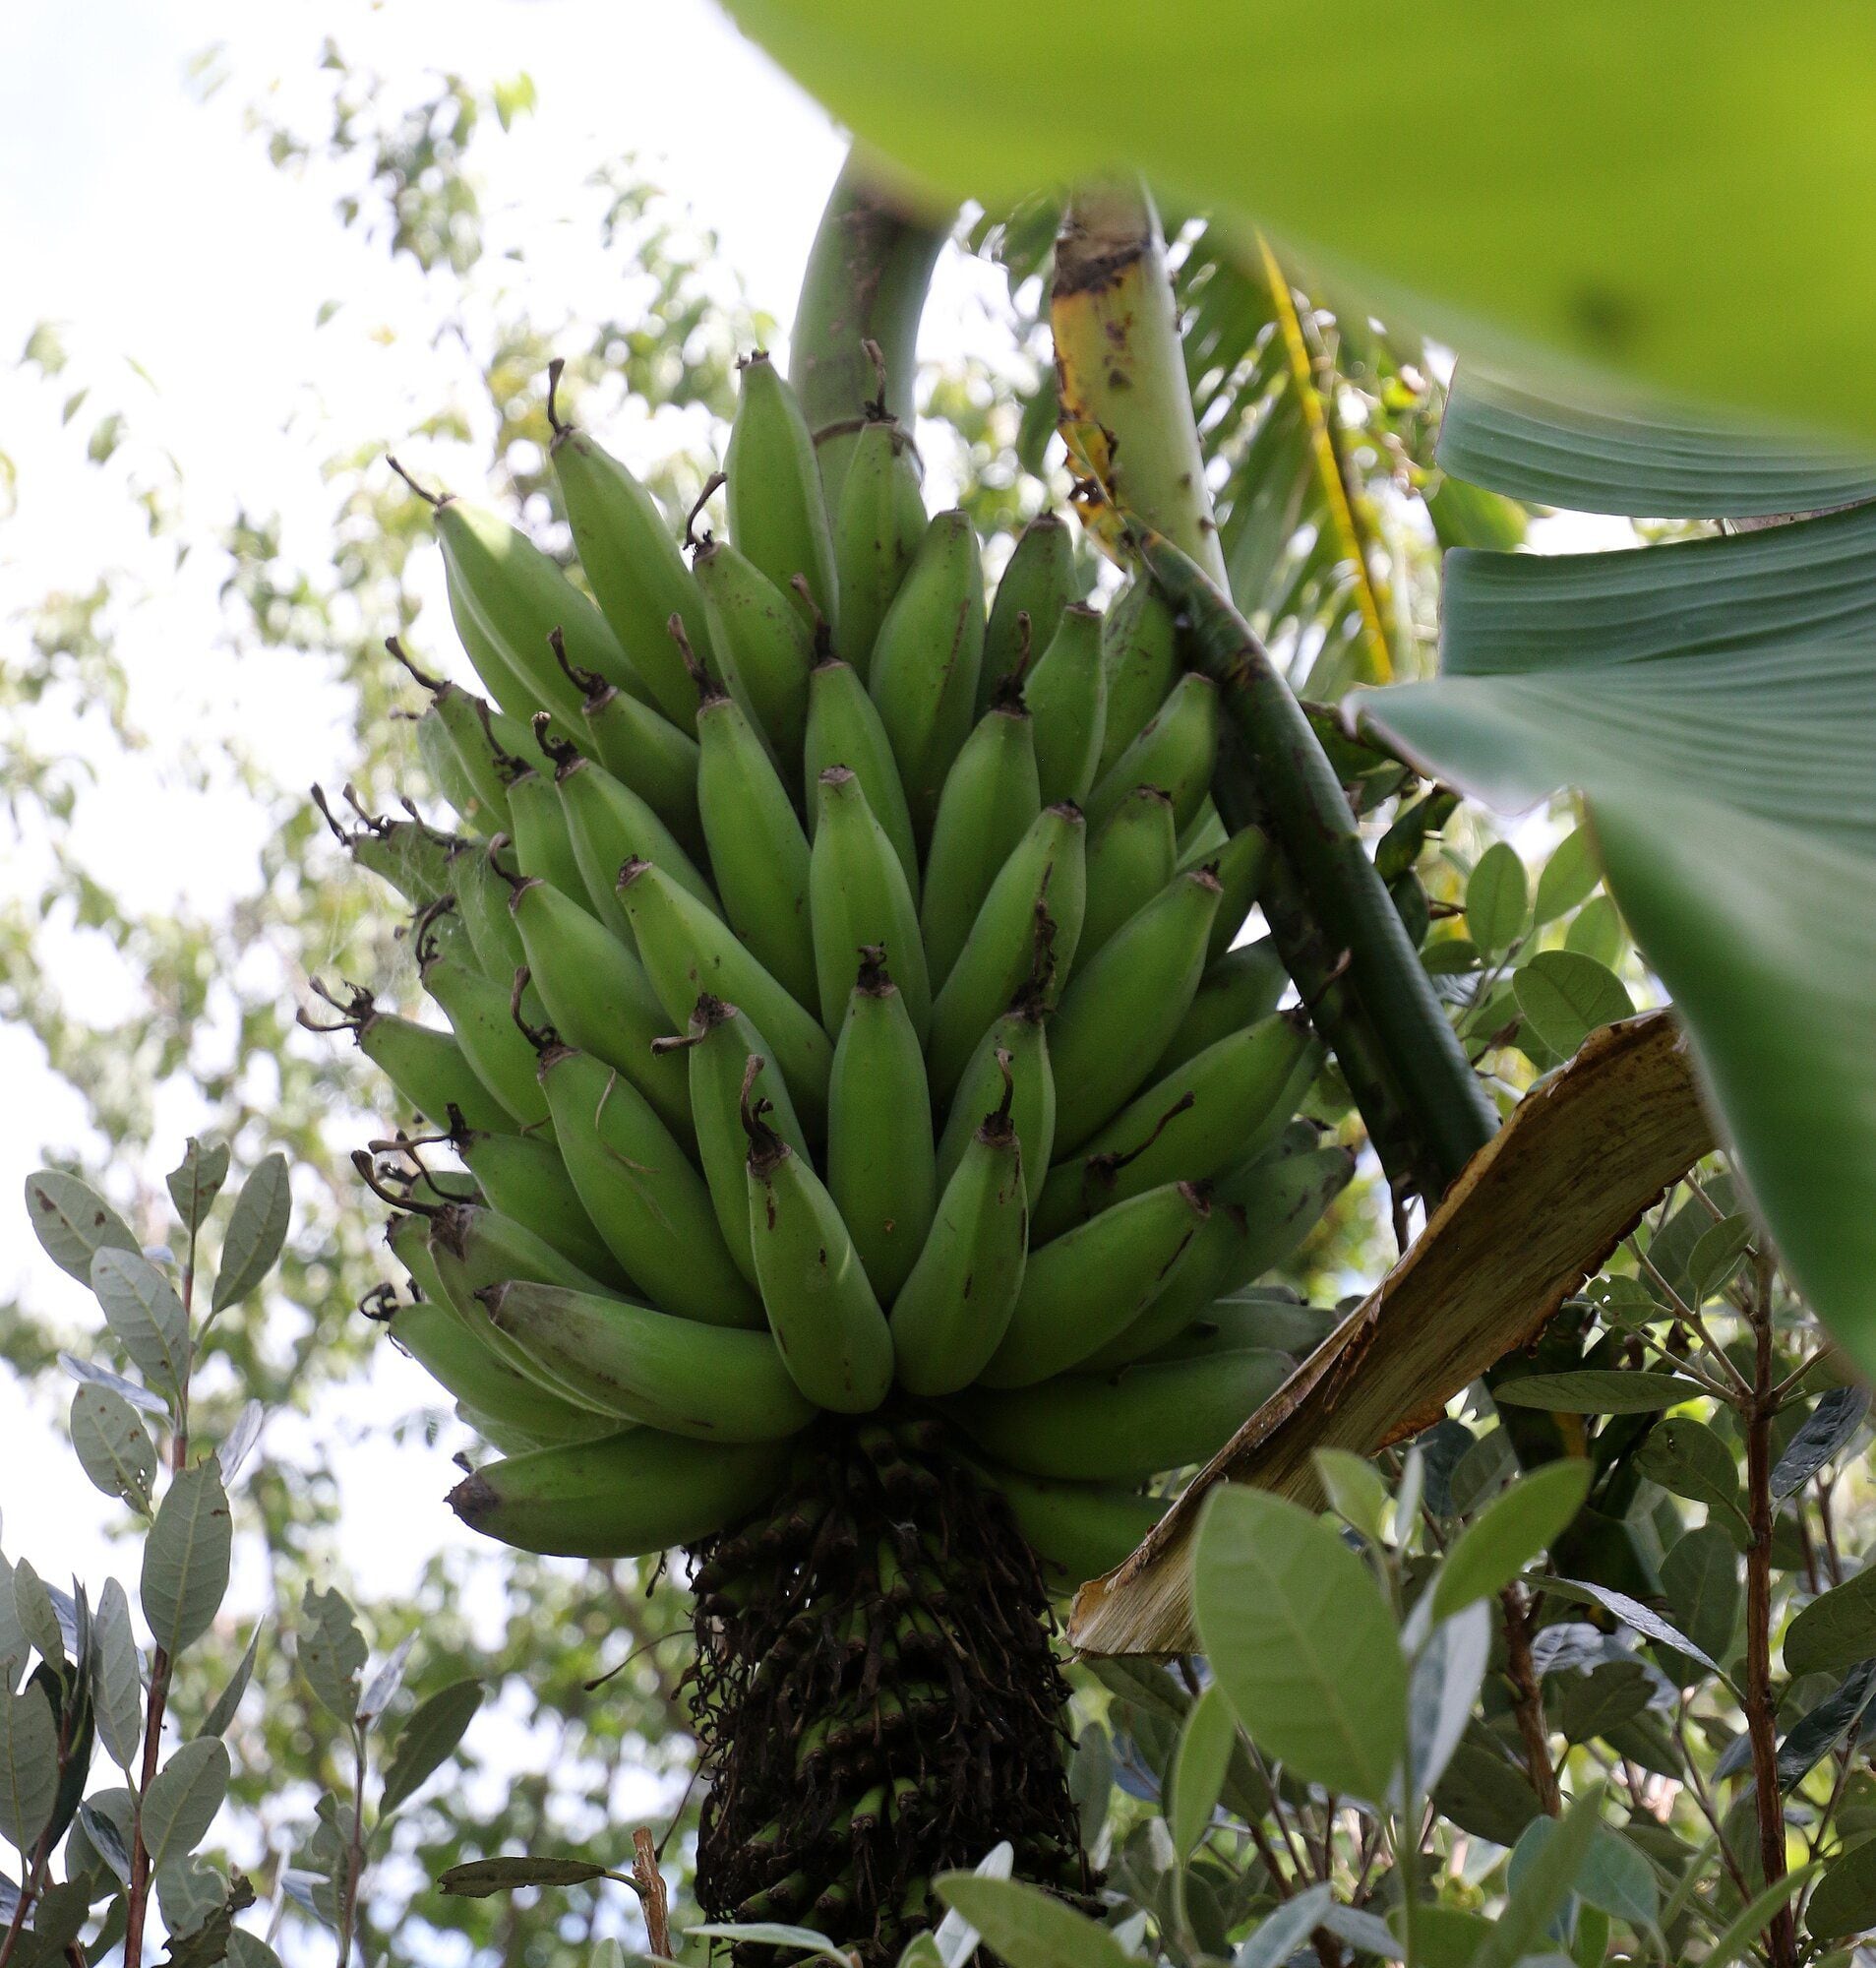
1136;533;1498;1200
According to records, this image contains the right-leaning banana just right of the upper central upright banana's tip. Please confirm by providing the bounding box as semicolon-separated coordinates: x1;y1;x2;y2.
919;691;1042;986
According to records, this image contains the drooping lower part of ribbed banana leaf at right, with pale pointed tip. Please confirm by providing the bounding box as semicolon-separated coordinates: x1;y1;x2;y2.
1357;638;1876;1372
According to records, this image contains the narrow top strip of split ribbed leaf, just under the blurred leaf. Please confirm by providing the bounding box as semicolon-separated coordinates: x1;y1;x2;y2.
1437;362;1876;520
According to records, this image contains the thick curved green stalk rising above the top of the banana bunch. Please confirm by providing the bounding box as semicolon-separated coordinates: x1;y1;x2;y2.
789;146;951;506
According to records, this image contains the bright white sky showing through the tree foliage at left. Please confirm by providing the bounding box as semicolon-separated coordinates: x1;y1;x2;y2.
0;0;880;1881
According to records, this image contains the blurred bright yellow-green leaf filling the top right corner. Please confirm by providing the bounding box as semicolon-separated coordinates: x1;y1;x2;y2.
728;0;1876;435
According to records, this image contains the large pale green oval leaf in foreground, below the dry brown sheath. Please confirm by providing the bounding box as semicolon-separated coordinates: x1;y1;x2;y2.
1191;1488;1406;1803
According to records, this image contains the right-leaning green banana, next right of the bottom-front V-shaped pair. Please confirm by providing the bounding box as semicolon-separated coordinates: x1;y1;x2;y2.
979;1183;1211;1387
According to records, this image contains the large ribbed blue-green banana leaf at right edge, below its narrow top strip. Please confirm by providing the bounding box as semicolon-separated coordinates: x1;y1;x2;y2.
1357;384;1876;1374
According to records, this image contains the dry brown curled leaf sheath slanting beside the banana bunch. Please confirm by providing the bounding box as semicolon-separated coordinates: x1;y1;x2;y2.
1067;1012;1713;1653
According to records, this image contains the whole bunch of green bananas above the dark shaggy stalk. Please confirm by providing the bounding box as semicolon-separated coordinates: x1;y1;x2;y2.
321;356;1353;1567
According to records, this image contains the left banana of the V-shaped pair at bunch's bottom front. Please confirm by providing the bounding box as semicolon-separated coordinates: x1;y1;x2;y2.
744;1059;893;1415
